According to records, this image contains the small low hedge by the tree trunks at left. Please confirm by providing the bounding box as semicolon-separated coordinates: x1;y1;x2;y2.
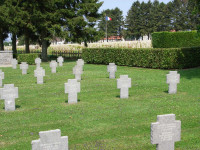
17;54;39;65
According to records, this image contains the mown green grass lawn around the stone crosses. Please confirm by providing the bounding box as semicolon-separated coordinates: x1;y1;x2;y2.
0;61;200;150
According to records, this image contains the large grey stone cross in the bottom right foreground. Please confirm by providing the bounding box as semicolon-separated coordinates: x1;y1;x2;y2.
151;114;181;150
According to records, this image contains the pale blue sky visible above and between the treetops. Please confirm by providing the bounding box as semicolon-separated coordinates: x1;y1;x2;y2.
99;0;172;18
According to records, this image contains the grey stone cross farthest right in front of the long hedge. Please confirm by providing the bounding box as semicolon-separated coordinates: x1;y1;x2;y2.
167;71;180;94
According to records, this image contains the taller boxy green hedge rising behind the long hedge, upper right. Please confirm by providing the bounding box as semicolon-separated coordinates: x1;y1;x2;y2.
152;31;200;48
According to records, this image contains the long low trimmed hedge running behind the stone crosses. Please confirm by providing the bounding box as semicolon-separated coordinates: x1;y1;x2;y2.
82;47;200;69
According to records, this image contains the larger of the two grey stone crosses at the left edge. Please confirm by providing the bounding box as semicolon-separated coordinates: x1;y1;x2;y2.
0;84;18;111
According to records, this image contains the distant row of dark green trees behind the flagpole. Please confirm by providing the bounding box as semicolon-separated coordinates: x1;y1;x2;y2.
98;0;200;39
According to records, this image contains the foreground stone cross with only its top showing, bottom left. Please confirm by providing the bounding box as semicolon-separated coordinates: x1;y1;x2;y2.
31;129;68;150
